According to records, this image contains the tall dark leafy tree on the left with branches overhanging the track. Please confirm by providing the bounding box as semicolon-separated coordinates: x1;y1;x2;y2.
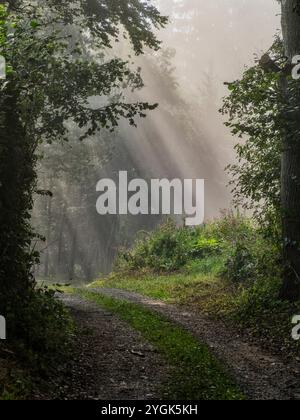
0;0;166;334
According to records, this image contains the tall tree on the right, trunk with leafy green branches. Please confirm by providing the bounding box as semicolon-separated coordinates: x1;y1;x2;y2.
223;0;300;301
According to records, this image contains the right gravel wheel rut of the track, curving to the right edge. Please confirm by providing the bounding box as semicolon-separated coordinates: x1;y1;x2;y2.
90;288;300;400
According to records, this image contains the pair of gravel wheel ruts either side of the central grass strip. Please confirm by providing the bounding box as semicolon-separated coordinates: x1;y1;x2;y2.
34;289;300;400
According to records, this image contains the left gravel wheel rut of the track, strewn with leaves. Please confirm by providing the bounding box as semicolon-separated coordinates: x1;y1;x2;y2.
46;294;169;400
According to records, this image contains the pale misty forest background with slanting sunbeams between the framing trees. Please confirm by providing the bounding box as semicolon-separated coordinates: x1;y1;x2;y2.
33;0;280;282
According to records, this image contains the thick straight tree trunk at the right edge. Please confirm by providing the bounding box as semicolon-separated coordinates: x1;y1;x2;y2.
281;0;300;301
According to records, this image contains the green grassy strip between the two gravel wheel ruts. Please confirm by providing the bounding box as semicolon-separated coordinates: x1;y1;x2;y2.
74;289;244;400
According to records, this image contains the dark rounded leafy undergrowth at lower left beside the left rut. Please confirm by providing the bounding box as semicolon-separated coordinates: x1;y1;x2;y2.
0;287;75;400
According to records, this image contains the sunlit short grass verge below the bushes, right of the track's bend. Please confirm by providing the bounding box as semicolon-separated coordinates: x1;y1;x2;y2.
88;256;237;316
